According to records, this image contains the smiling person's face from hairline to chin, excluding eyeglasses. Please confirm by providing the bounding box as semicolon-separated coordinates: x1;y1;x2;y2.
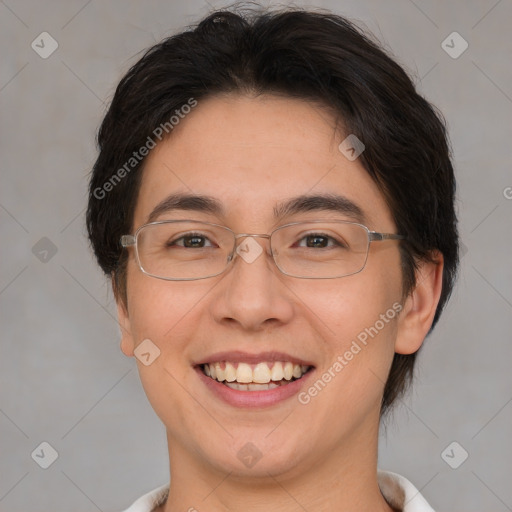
119;96;418;482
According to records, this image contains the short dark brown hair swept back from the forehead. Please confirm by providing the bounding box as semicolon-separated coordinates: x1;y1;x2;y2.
87;6;458;411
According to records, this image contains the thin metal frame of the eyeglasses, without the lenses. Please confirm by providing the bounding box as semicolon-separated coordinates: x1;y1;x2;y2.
119;219;407;281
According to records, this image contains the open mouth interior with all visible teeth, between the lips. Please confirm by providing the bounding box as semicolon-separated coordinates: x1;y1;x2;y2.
199;361;313;392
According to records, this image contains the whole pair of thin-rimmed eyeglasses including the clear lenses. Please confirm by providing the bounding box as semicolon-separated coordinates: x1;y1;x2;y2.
121;220;406;281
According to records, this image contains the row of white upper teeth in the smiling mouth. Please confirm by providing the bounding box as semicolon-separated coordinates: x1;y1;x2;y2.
203;361;309;384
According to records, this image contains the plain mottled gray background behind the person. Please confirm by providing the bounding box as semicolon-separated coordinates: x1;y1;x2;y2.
0;0;512;512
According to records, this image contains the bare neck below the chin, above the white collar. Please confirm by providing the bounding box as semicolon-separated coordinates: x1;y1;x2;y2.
158;416;393;512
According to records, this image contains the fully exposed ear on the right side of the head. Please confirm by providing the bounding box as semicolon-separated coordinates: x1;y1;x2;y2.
395;252;444;354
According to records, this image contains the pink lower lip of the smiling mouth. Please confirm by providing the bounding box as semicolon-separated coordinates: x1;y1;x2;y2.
195;367;313;407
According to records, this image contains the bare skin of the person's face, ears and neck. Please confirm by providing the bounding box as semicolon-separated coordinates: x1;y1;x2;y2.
118;95;443;512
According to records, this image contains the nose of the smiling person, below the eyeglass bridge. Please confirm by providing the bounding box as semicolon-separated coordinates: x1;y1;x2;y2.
211;236;294;331
